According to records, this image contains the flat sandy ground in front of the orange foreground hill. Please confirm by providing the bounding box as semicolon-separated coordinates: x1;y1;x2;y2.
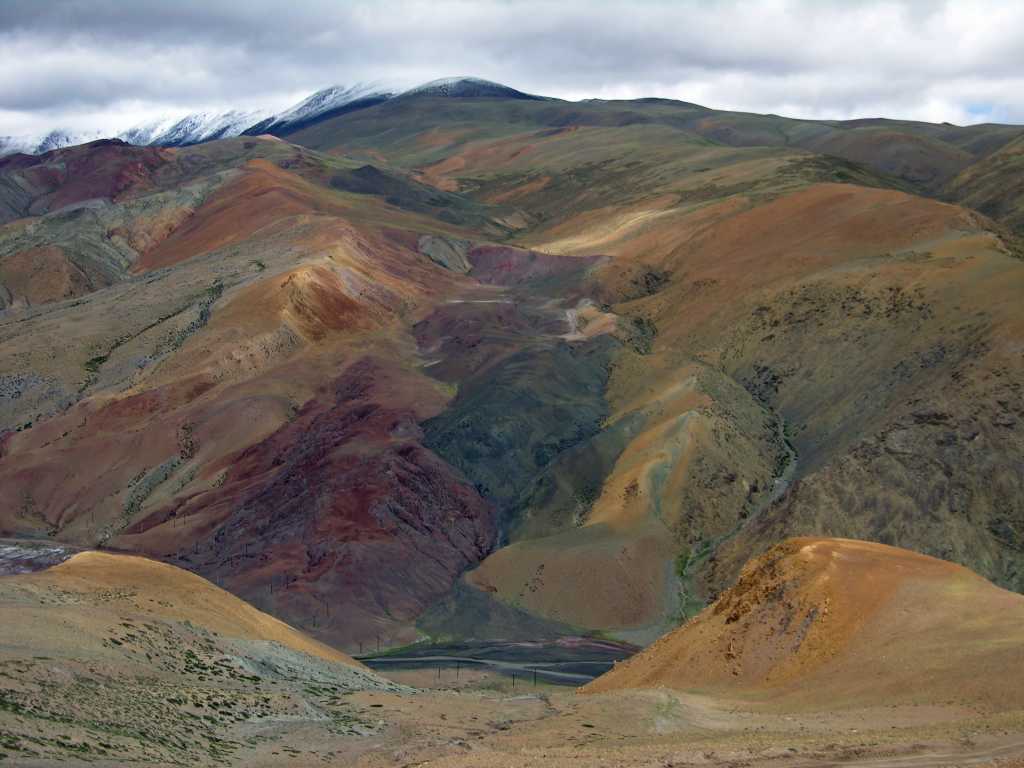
235;673;1024;768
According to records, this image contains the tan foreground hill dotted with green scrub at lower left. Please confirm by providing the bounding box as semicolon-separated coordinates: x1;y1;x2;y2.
0;545;399;765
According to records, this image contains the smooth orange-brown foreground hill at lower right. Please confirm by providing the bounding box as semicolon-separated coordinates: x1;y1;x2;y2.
584;539;1024;711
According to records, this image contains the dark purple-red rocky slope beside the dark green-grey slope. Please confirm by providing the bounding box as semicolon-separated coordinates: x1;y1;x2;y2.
115;358;497;649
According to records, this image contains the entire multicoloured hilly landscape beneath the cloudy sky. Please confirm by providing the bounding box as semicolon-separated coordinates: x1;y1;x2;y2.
0;79;1024;767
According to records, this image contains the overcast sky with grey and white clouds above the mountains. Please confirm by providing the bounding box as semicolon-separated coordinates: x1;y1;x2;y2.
0;0;1024;140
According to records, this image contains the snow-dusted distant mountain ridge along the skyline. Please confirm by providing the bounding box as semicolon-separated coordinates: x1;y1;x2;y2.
0;77;543;157
